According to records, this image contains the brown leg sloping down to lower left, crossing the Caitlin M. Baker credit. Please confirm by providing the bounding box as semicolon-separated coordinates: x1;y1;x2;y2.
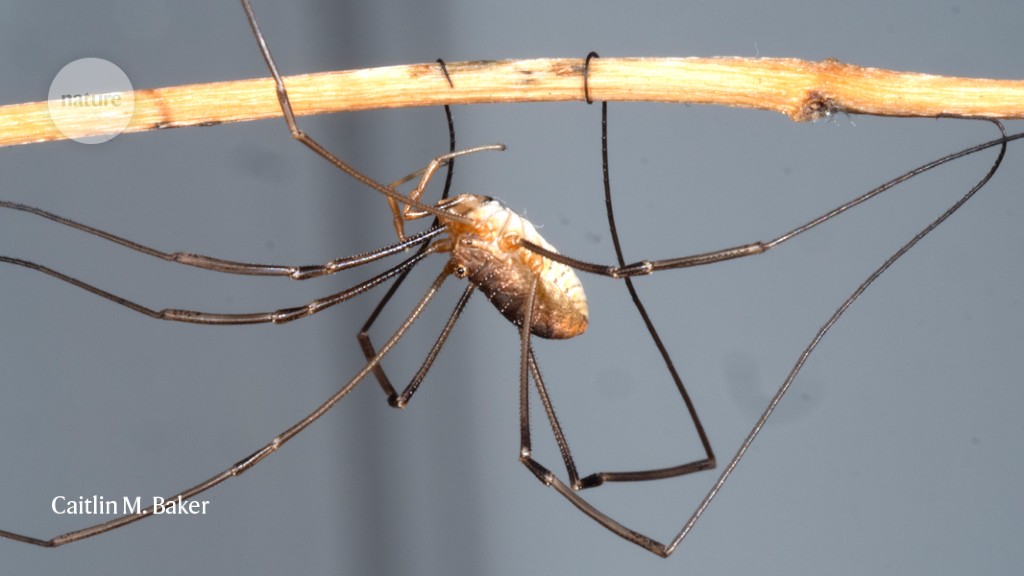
0;271;449;548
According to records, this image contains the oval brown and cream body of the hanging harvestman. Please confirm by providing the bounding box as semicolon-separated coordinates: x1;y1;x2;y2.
444;194;589;338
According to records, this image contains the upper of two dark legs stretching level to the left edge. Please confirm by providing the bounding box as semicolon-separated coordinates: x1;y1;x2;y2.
0;200;444;280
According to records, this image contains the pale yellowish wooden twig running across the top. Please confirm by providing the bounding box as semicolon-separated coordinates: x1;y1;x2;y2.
0;57;1024;147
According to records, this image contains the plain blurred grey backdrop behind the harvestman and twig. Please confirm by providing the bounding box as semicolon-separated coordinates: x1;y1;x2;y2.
0;1;1024;574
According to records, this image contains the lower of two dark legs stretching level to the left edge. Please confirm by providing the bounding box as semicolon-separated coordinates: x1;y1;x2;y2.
0;249;431;325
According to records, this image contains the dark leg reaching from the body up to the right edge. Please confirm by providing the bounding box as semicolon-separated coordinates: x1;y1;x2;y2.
519;128;1024;278
